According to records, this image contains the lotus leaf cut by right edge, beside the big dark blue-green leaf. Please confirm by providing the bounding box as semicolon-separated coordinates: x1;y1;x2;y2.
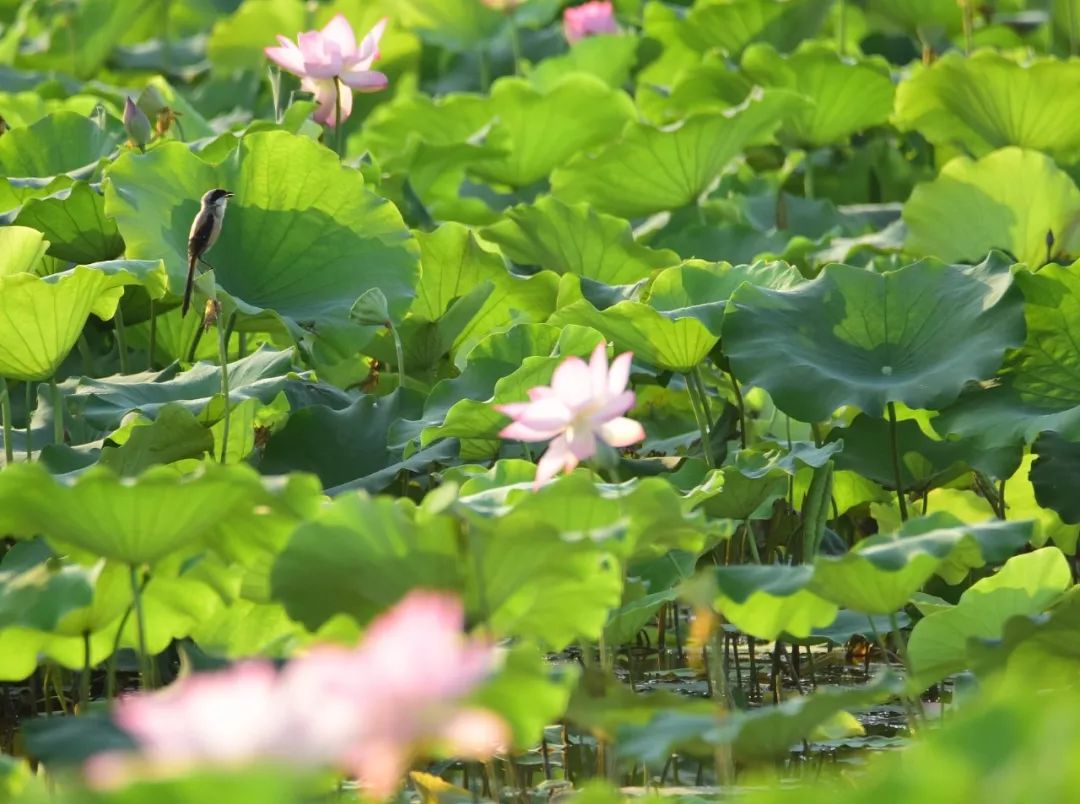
936;264;1080;445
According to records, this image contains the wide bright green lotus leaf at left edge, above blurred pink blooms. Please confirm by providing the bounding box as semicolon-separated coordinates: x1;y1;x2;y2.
0;464;282;564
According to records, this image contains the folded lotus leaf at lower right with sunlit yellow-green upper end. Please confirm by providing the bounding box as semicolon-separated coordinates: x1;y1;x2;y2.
907;547;1072;683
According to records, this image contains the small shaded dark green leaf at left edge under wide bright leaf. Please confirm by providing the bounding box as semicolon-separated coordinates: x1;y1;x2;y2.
0;541;102;631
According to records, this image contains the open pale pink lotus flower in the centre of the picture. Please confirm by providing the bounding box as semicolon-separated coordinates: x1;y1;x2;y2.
495;343;645;487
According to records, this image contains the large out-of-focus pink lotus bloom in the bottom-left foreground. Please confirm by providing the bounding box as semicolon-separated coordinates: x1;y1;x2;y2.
85;591;508;796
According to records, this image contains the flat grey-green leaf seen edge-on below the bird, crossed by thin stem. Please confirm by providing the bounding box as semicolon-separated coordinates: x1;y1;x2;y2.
60;347;294;431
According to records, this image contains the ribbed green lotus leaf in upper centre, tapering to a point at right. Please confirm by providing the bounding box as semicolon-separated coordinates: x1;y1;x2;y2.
484;196;679;285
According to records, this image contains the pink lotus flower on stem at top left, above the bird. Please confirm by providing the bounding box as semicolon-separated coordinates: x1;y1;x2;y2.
264;14;389;126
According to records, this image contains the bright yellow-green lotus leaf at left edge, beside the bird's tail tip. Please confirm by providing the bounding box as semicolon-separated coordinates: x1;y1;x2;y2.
0;260;164;380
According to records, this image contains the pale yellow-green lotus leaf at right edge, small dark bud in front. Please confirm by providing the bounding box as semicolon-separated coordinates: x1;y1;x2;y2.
903;147;1080;267
